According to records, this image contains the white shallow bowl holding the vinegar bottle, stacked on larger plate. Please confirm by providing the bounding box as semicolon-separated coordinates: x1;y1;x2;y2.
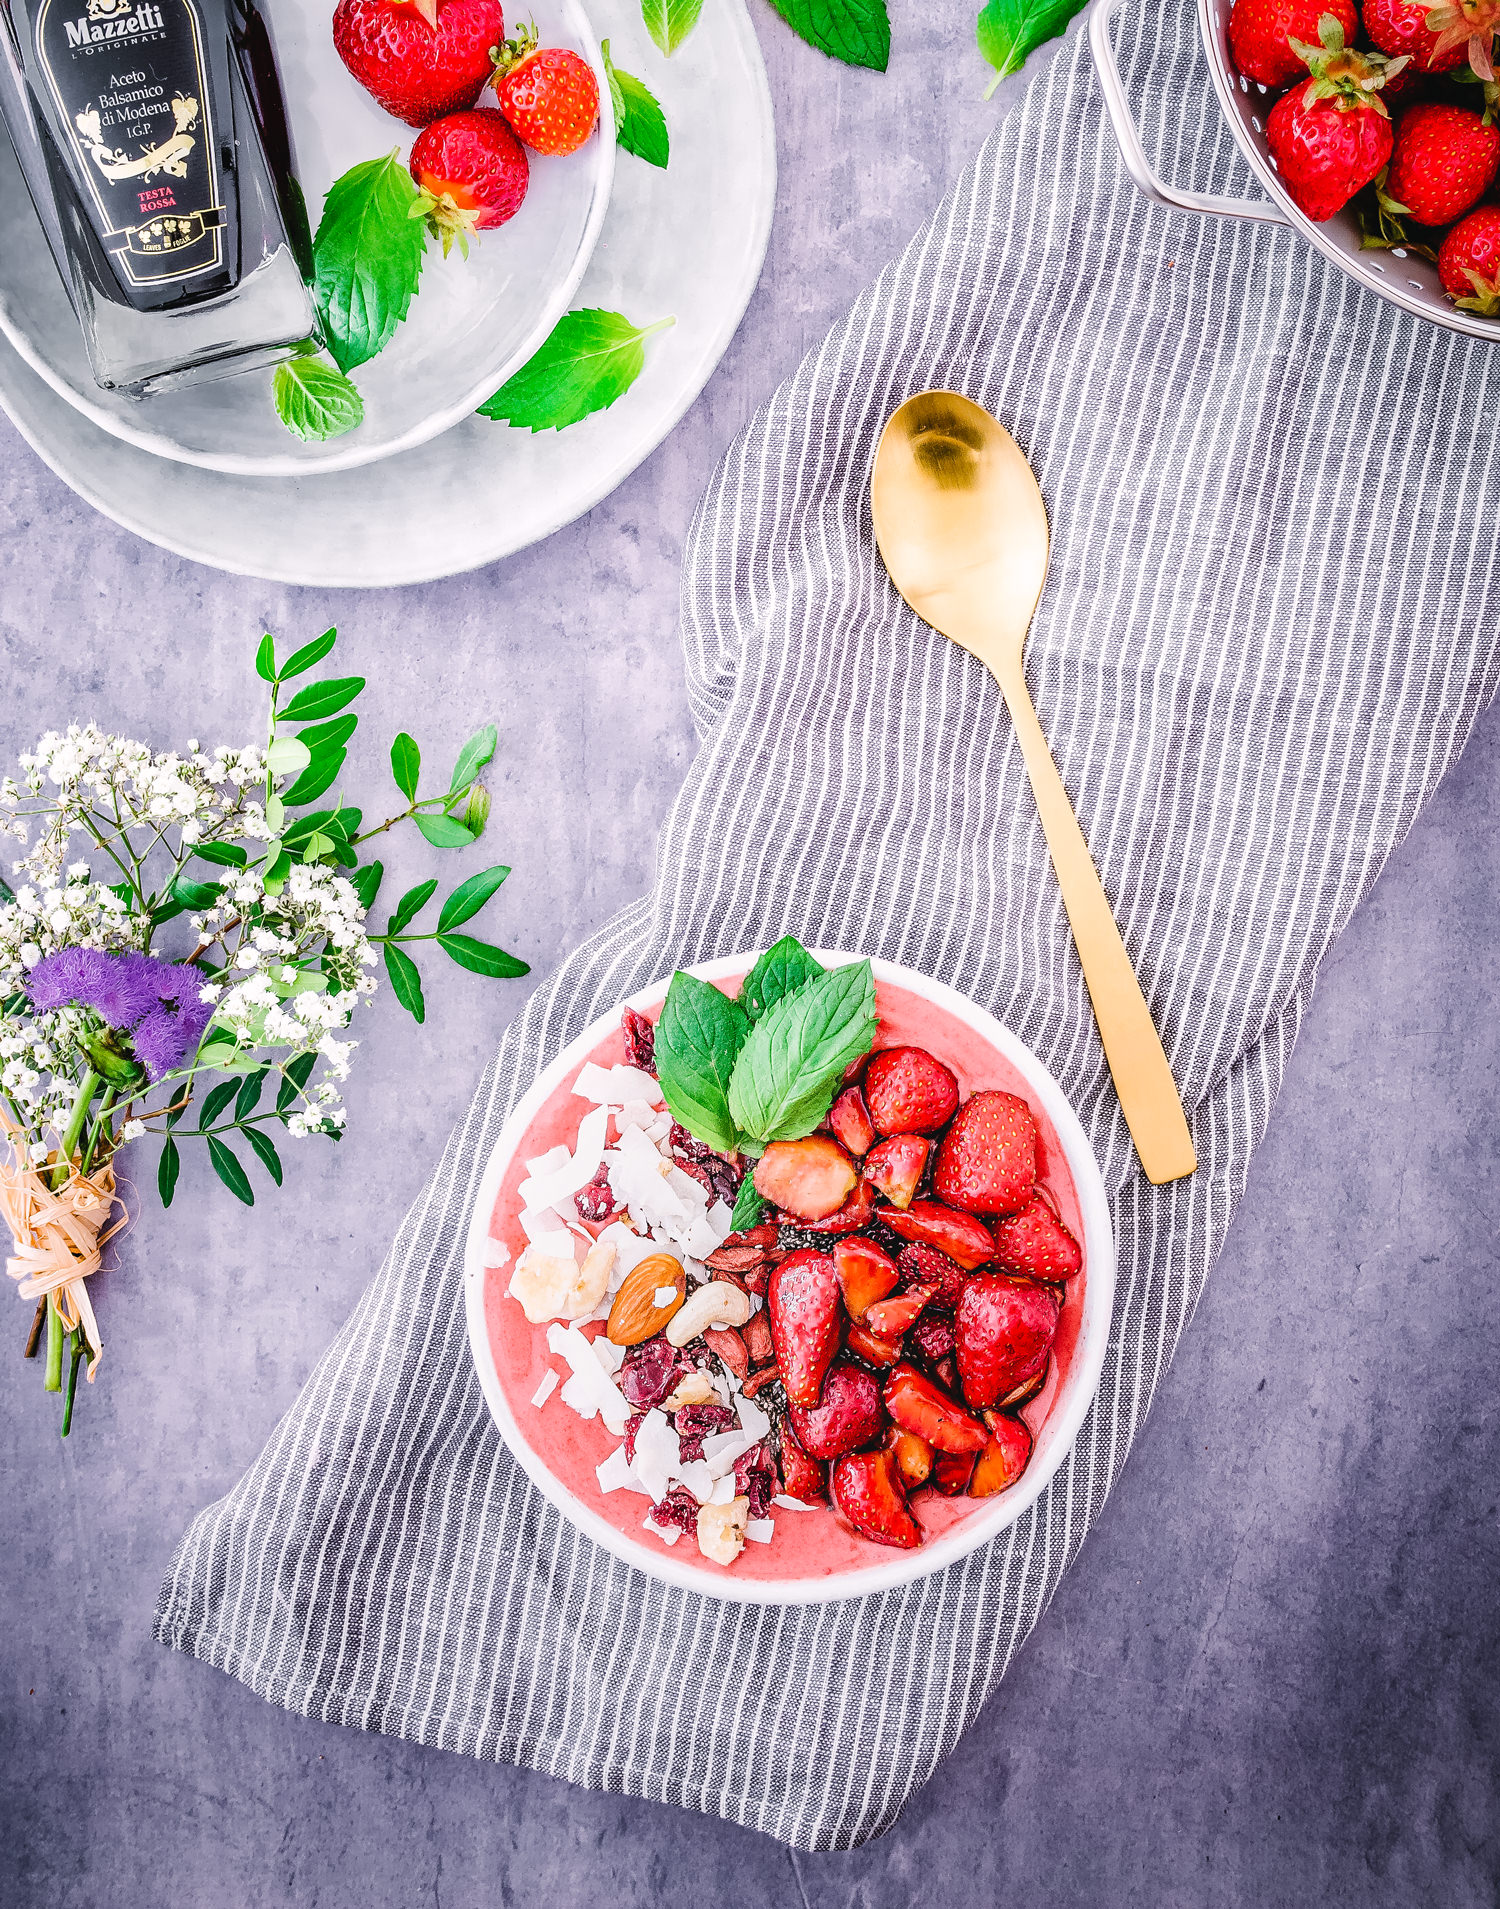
0;0;615;477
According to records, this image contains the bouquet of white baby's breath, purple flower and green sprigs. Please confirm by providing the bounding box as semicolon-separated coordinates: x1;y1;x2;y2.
0;630;529;1436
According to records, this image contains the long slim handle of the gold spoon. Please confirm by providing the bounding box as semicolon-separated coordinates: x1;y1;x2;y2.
994;664;1198;1185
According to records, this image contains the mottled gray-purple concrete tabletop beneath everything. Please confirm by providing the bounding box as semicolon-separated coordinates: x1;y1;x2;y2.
0;8;1500;1909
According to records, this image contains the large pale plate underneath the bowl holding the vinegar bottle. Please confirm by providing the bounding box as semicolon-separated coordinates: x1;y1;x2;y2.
0;0;777;588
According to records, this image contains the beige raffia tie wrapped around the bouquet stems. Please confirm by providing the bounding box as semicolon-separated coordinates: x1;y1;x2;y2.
0;1111;128;1384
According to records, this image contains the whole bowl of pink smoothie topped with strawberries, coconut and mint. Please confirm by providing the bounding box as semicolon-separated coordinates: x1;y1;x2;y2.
464;937;1115;1604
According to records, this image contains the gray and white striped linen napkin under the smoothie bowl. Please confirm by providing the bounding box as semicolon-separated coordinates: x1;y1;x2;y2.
156;0;1500;1850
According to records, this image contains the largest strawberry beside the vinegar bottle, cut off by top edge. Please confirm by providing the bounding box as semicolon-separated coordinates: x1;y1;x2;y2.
334;0;506;126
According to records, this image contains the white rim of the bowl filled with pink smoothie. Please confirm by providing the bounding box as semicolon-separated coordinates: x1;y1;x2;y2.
464;949;1115;1604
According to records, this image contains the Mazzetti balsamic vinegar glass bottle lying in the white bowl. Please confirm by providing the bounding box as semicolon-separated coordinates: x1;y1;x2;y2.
0;0;317;393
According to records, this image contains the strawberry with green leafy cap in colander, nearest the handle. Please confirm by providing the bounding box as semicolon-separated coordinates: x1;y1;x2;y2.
1265;15;1406;221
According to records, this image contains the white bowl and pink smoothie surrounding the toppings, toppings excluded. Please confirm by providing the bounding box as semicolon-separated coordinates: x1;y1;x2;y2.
466;951;1115;1602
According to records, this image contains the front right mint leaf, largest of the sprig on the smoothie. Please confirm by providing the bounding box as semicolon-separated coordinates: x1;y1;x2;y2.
725;960;876;1142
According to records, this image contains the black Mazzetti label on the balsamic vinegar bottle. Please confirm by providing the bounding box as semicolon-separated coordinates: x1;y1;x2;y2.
36;0;223;284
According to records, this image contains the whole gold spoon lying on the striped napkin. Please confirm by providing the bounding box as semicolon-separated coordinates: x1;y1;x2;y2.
870;391;1198;1185
